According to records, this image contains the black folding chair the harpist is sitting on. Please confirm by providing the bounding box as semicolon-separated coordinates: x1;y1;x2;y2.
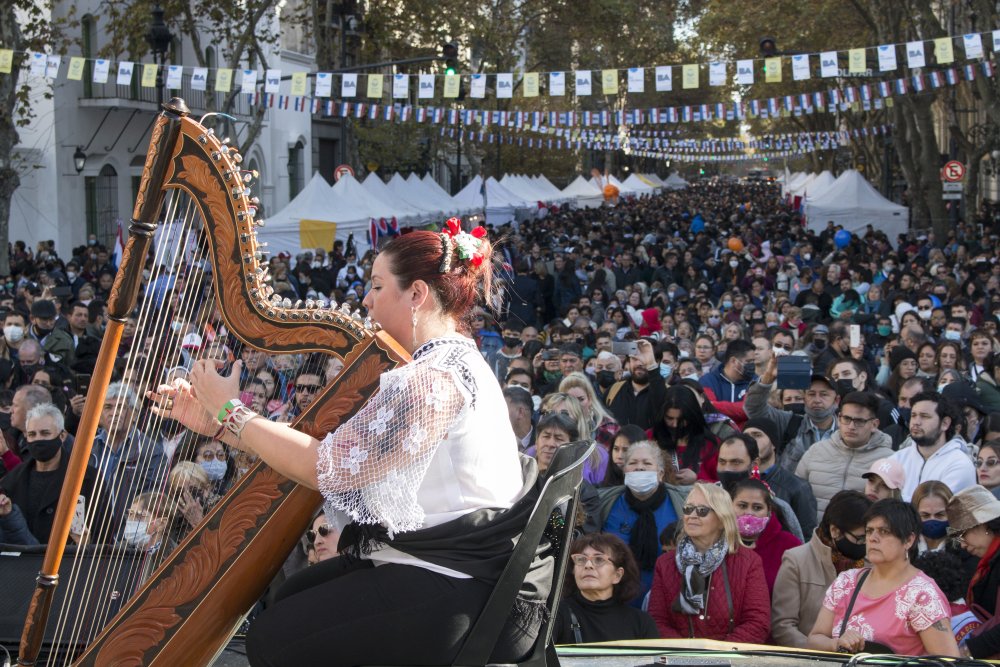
453;441;595;665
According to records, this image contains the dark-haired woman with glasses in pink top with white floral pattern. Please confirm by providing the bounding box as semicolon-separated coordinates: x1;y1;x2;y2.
807;498;959;657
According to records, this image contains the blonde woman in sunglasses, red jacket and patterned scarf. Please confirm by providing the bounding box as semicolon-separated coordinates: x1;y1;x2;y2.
649;483;771;644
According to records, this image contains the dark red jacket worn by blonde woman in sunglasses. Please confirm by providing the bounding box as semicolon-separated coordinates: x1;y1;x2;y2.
649;547;771;644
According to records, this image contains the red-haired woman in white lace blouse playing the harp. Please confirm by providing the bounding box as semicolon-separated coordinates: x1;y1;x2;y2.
150;226;545;667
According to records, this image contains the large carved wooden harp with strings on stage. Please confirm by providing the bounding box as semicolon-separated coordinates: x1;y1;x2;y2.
18;98;408;665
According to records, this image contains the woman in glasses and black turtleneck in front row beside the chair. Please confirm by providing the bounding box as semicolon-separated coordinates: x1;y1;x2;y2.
552;533;660;644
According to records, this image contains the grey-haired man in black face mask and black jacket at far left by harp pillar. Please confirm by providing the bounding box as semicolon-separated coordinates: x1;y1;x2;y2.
0;403;103;544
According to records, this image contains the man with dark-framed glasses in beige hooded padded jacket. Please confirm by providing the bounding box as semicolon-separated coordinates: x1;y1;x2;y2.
795;391;896;528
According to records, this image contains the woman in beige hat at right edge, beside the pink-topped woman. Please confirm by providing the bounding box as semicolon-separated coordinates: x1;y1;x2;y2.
948;485;1000;659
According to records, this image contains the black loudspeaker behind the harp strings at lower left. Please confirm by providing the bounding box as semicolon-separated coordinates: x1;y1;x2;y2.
0;544;144;654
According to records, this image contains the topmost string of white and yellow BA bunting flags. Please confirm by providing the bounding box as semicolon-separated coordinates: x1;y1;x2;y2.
0;30;1000;103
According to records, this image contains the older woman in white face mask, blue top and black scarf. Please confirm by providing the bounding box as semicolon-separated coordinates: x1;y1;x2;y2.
598;440;684;606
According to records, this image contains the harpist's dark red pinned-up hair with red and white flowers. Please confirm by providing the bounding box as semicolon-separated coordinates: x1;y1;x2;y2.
381;230;493;331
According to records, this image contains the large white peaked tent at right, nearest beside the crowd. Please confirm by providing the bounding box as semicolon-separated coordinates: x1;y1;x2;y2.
805;169;910;244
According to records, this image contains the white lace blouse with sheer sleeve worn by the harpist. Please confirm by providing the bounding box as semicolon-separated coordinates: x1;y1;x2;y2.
317;336;522;576
